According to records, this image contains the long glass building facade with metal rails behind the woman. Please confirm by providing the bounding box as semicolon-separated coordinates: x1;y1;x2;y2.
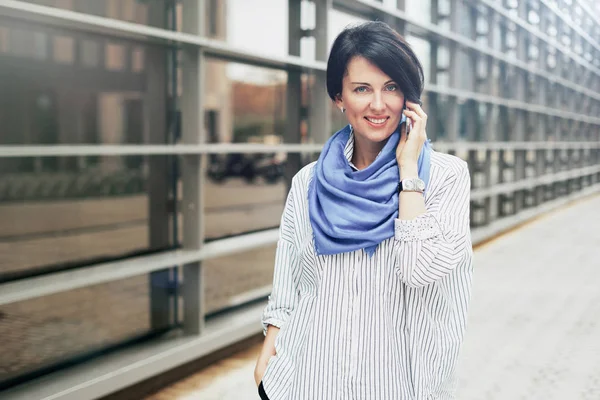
0;0;600;399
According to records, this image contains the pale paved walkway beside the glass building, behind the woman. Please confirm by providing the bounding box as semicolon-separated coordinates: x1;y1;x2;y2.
146;196;600;400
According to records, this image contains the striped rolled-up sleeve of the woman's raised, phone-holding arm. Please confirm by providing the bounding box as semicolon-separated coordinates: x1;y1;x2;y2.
394;162;472;287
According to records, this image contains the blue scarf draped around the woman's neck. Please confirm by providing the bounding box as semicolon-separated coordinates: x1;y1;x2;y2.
308;119;432;256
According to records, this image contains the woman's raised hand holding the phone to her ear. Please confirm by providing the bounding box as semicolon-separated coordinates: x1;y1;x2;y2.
396;101;427;166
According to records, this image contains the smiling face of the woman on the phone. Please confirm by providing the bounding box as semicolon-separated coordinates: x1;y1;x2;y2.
336;56;404;143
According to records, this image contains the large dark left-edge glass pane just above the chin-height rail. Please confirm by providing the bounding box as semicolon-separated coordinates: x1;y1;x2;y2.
0;24;167;144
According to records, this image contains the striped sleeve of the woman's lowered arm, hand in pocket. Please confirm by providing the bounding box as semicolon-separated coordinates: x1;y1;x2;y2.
262;180;300;335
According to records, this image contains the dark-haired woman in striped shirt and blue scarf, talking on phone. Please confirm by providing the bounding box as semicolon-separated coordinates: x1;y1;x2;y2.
255;22;472;400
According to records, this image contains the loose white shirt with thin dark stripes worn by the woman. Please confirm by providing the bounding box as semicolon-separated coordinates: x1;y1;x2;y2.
262;135;472;400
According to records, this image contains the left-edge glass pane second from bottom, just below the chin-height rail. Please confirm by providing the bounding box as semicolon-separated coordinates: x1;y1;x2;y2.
0;156;169;281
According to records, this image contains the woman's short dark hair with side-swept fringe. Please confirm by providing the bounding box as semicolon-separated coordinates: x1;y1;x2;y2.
327;21;424;104
